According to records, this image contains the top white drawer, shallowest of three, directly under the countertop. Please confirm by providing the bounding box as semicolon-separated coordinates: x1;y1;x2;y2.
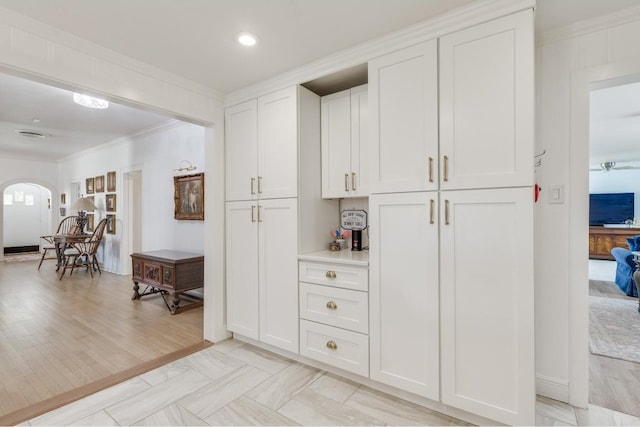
299;261;369;291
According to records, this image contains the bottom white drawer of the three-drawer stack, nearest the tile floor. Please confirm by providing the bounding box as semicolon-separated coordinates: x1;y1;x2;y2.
300;320;369;377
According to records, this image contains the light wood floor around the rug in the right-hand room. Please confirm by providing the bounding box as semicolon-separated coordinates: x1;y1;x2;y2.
589;280;640;417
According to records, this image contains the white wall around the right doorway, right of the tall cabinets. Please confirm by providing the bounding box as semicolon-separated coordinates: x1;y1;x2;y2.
535;4;640;405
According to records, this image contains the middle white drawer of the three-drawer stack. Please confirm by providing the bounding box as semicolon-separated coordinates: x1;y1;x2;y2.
299;283;369;334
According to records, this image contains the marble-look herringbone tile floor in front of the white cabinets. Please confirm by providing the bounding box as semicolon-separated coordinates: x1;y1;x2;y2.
24;340;640;426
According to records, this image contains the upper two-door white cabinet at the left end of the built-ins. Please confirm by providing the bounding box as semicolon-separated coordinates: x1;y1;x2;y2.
225;86;298;201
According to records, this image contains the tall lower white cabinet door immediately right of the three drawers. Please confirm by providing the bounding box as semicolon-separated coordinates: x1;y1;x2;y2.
369;192;440;400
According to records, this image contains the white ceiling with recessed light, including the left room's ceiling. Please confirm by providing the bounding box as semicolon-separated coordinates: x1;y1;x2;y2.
0;0;638;159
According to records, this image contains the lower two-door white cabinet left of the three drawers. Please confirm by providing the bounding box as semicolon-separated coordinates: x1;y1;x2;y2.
226;199;298;352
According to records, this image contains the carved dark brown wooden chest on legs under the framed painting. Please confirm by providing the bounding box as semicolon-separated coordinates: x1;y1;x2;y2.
131;249;204;314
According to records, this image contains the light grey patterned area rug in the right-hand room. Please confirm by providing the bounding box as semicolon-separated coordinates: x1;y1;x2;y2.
589;296;640;363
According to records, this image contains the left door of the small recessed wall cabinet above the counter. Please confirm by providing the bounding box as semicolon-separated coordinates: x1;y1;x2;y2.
320;89;351;198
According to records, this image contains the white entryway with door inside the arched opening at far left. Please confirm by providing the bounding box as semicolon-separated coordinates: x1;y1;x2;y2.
3;184;51;248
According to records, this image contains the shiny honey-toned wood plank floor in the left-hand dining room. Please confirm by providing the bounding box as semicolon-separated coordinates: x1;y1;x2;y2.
0;260;203;424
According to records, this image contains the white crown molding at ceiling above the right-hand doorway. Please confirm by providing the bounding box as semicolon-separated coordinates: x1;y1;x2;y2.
536;2;640;46
